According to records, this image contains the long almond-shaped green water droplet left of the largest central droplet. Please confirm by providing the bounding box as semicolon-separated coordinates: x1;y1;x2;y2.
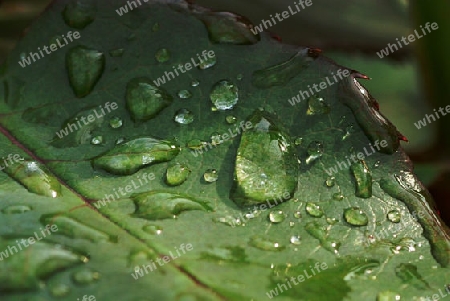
92;137;181;175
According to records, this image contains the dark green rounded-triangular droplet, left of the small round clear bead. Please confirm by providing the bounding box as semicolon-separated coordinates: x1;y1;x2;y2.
126;77;173;121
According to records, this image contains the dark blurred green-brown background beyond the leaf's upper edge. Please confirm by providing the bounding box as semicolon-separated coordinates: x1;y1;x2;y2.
0;0;450;225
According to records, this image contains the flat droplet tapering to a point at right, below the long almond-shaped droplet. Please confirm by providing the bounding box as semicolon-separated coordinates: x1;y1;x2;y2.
131;191;211;220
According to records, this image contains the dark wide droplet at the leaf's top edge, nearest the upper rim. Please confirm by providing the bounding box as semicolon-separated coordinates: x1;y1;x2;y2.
197;12;260;45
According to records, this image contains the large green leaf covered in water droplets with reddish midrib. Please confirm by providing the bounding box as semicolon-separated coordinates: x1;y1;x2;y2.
0;0;450;301
